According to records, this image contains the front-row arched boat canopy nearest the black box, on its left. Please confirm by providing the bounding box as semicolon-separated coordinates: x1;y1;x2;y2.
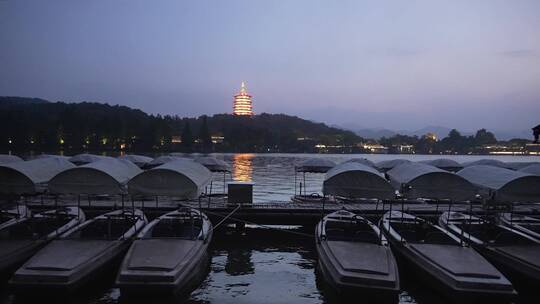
128;159;212;199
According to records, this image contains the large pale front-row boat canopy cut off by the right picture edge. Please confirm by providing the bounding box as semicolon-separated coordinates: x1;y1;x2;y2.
457;165;540;202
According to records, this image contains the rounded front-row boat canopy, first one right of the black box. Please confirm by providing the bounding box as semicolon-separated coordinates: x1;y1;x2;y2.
323;162;395;199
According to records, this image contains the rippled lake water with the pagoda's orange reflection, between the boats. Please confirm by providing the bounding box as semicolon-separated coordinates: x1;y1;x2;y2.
0;154;540;304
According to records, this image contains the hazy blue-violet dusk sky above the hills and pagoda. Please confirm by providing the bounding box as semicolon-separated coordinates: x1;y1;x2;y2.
0;0;540;130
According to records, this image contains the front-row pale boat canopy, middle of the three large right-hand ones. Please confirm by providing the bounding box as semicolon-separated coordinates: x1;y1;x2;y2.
386;162;477;201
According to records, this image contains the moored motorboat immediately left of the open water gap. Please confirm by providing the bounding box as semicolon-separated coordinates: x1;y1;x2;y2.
116;211;213;298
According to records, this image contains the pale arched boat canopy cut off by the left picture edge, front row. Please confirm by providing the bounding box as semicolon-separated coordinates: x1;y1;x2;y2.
0;157;75;195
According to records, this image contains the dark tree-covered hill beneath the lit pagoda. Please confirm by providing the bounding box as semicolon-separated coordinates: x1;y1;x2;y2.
0;97;361;152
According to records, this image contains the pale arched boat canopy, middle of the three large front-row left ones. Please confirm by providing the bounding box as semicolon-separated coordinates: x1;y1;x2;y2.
49;157;142;195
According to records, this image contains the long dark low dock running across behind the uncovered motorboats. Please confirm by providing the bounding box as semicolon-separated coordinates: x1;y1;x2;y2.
5;197;540;225
